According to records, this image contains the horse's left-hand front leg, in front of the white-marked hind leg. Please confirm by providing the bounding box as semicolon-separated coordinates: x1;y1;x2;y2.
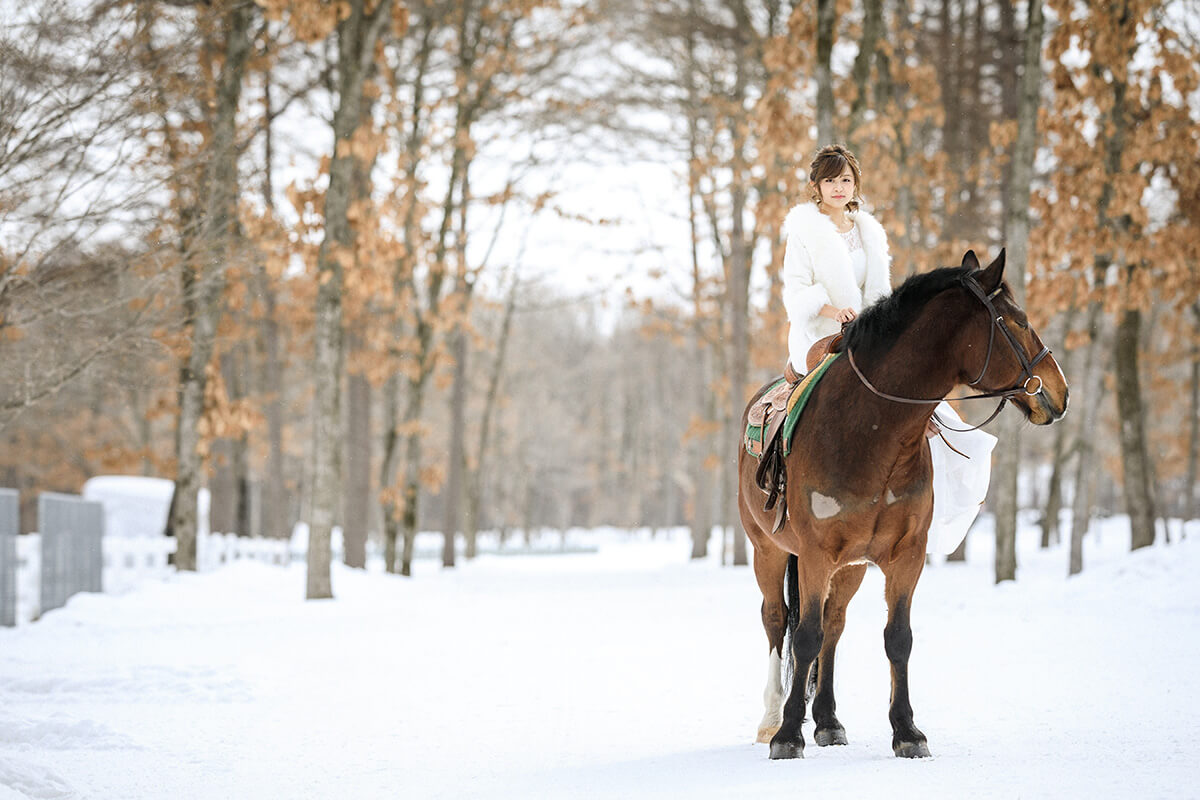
770;553;830;758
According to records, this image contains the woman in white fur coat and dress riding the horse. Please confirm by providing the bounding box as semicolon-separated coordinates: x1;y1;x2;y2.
784;144;996;554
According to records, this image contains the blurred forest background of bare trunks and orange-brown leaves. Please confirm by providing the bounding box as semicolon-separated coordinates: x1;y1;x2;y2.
0;0;1200;587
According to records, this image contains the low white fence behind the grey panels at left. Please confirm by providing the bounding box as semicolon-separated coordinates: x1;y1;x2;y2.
17;534;290;624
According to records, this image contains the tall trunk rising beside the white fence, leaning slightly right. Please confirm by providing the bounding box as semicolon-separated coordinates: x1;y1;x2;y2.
169;4;253;571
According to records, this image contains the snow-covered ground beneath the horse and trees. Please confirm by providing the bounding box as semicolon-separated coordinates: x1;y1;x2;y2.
0;521;1200;800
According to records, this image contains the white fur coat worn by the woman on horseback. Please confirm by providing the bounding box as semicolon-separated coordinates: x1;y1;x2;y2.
784;203;892;371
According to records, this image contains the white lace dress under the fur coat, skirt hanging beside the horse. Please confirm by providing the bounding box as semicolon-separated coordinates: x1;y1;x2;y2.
838;225;996;555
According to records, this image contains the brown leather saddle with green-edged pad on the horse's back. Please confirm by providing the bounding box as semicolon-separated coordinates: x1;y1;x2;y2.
745;333;841;534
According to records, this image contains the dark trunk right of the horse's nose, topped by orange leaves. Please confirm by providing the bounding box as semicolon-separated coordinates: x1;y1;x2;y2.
1115;308;1154;549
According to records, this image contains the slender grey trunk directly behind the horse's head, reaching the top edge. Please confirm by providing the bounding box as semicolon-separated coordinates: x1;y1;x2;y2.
992;0;1044;583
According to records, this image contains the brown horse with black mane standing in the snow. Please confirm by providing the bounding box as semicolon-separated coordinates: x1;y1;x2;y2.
738;251;1067;758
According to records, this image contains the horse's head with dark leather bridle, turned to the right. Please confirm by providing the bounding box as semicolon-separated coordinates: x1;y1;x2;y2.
962;249;1068;425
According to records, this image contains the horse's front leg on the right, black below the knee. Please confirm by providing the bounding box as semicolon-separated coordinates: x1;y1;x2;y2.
883;542;929;758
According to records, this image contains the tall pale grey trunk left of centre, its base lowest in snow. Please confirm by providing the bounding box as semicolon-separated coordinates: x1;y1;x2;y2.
306;0;391;600
